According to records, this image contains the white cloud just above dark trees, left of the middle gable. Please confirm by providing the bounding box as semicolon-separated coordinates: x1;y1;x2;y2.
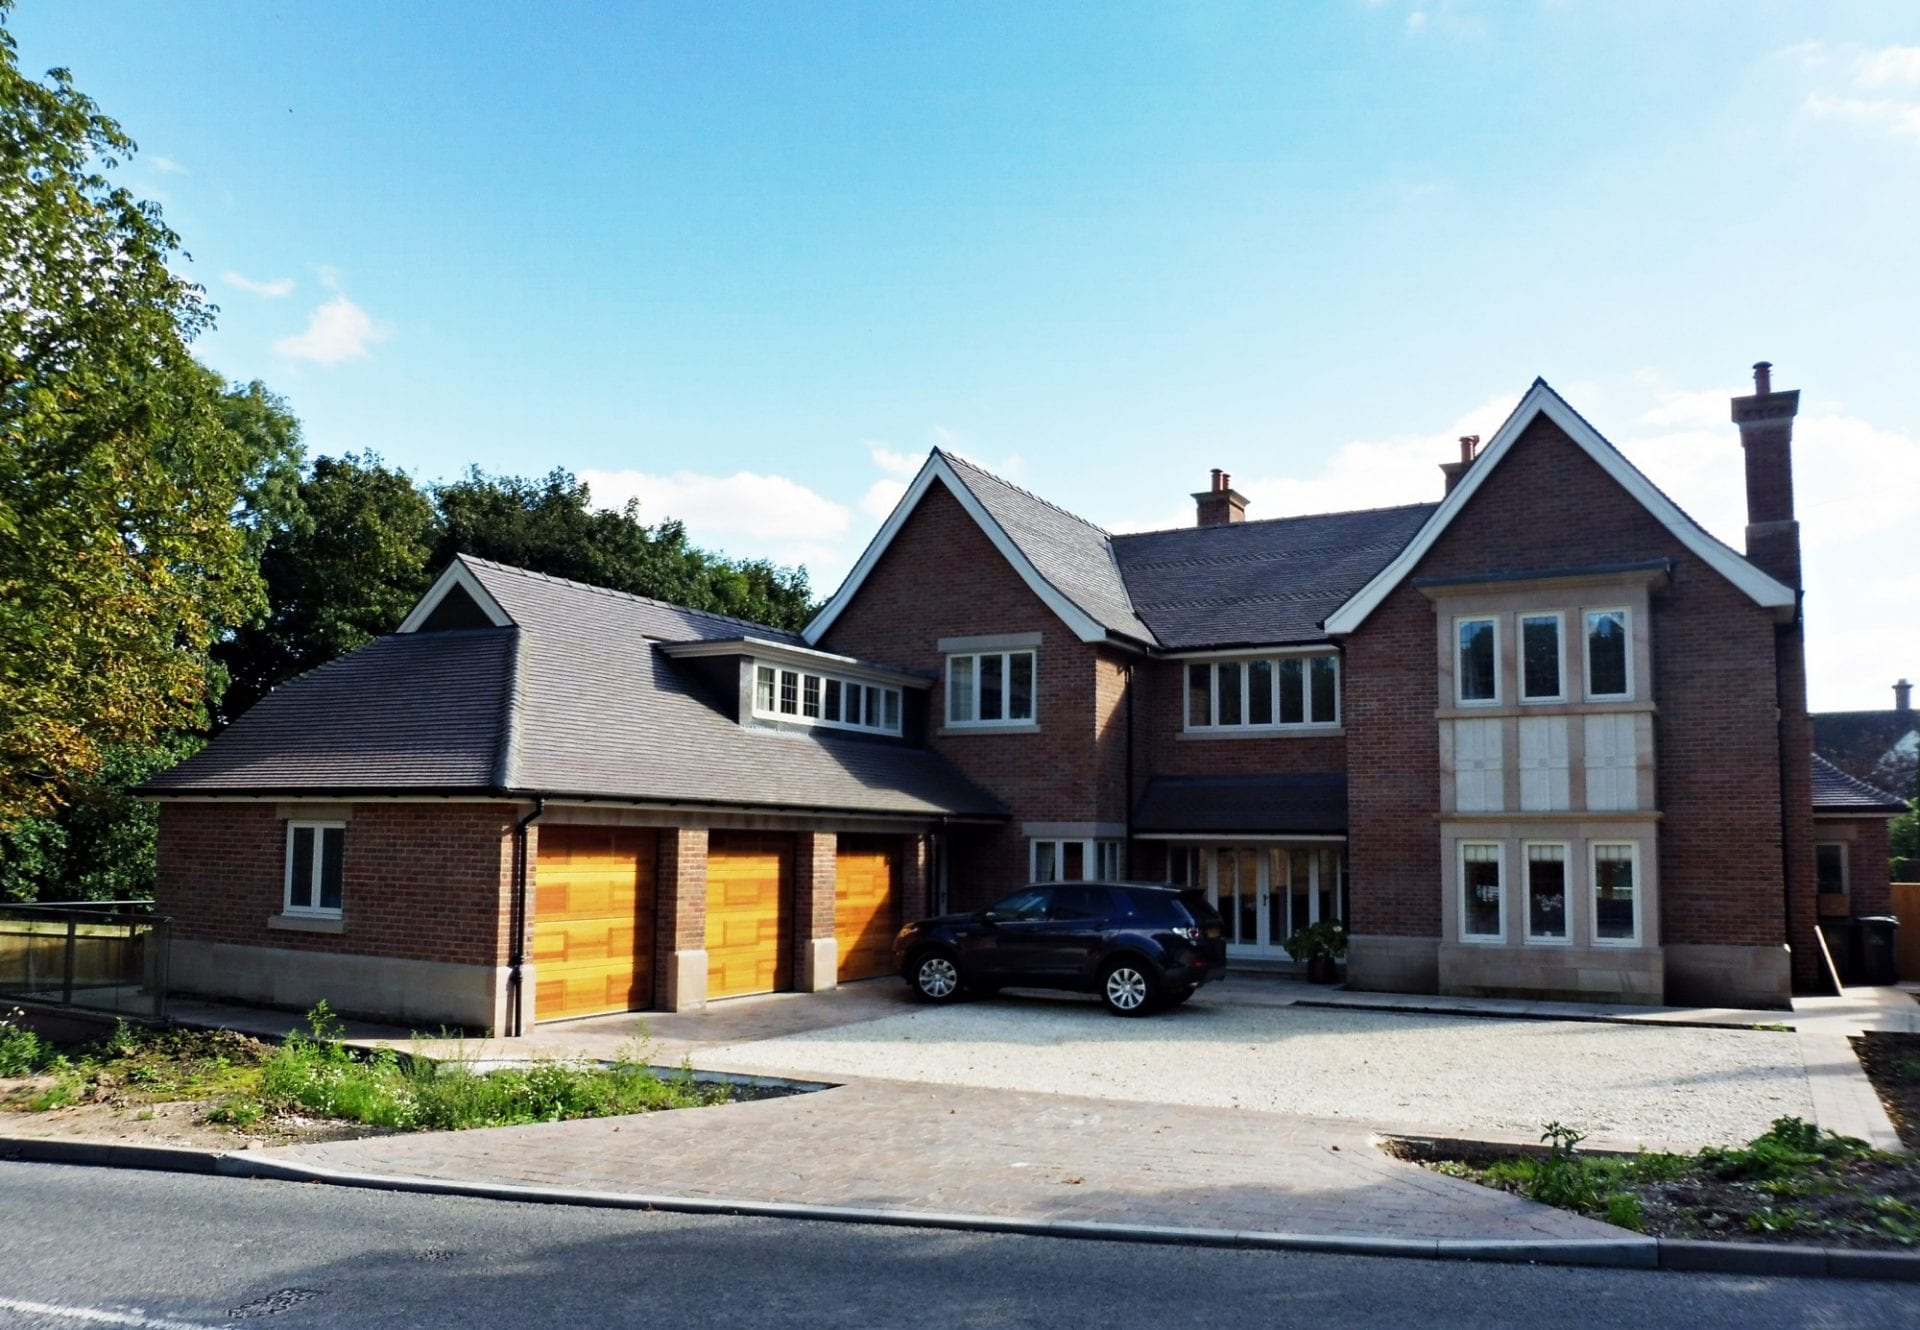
580;470;852;571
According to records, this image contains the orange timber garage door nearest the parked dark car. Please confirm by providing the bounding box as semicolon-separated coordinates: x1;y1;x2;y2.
707;831;793;998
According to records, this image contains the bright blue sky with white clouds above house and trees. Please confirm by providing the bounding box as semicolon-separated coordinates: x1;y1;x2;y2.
10;0;1920;708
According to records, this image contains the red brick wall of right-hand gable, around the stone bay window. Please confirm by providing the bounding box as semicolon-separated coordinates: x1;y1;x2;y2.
1346;418;1811;950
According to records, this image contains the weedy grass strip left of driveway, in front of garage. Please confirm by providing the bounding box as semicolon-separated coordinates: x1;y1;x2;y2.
0;1002;732;1130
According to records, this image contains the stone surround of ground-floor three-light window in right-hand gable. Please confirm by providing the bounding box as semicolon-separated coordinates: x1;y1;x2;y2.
1440;814;1661;952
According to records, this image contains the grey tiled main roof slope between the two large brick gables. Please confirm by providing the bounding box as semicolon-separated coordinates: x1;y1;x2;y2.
1114;503;1440;651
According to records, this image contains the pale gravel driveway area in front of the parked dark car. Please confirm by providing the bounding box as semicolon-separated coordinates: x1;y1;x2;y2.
701;996;1812;1148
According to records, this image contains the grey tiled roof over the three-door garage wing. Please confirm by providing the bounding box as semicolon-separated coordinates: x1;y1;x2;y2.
142;558;1006;818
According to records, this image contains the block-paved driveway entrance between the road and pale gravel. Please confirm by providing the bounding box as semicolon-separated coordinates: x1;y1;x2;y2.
263;1081;1622;1240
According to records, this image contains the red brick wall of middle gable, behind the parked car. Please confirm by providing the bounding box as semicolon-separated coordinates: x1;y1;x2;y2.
820;484;1125;910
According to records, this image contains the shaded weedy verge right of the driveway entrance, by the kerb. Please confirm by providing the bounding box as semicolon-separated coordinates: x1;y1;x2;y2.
1400;1117;1920;1247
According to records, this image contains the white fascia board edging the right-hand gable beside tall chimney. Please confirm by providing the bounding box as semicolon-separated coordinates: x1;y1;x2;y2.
1325;380;1795;633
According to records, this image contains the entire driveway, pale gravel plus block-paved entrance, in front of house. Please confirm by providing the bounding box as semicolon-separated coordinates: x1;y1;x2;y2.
271;981;1811;1240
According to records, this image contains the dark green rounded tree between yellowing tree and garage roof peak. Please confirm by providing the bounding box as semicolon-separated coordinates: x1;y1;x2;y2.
213;453;436;720
